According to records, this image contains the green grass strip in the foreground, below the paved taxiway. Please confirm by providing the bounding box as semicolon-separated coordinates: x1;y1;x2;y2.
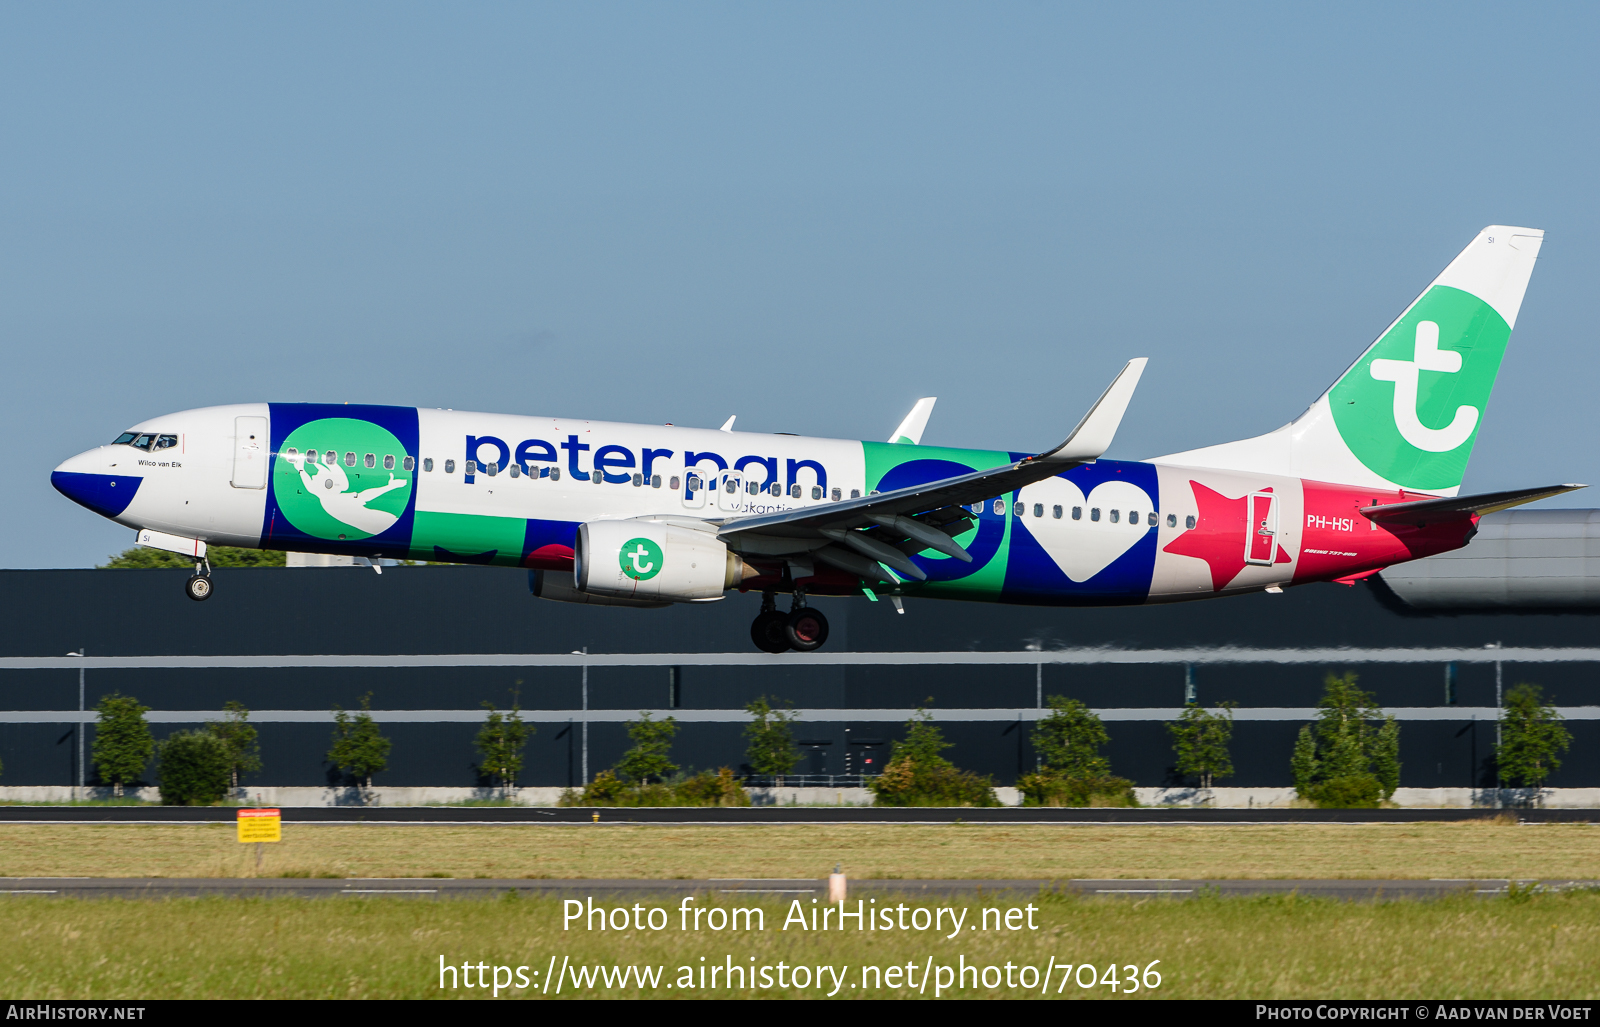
0;893;1600;1001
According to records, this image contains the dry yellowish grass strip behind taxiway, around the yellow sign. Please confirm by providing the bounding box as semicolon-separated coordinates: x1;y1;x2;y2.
0;821;1600;880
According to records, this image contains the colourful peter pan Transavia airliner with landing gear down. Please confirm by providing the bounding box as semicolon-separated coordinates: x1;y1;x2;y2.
51;226;1584;653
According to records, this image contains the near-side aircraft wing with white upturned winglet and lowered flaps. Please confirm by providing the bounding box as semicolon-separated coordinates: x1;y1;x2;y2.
718;357;1146;581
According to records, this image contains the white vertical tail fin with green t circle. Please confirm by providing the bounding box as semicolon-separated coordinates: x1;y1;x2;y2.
1160;226;1544;496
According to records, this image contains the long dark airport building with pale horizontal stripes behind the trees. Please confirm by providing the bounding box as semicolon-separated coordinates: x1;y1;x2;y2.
0;510;1600;793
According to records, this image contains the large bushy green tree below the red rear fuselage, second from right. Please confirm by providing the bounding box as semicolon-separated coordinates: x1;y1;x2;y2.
1290;673;1400;806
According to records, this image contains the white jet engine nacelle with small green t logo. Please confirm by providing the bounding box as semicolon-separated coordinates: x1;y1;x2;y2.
573;520;758;603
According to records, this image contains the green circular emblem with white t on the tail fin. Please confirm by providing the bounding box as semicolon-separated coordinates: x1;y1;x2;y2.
1328;285;1510;490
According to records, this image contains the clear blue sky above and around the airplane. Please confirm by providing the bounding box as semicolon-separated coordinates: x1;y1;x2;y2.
0;2;1600;566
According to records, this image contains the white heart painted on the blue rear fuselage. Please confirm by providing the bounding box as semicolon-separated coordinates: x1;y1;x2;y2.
1021;478;1155;582
